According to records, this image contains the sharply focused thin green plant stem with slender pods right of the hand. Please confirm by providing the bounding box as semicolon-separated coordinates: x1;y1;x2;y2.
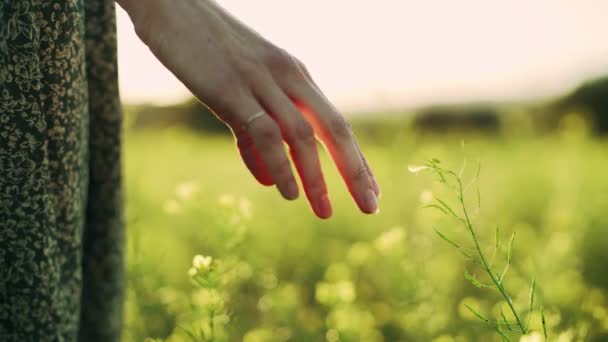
409;159;547;341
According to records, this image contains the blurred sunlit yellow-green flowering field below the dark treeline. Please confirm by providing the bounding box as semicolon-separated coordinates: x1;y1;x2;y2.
124;125;608;342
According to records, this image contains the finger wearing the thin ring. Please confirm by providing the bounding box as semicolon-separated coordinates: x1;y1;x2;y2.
230;96;298;200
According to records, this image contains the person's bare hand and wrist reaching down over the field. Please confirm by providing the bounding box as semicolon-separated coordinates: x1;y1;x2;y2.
117;0;380;218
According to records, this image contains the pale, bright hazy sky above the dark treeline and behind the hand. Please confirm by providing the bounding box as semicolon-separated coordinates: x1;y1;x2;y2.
118;0;608;110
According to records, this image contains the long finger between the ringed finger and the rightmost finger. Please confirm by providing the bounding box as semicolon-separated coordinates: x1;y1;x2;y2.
254;77;332;219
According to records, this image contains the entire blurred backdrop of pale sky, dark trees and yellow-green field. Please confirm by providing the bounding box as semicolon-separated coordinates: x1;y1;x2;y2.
118;0;608;342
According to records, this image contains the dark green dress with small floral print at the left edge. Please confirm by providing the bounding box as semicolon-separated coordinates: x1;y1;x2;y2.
0;0;124;342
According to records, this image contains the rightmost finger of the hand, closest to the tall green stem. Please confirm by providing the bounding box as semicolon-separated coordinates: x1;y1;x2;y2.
285;79;378;214
